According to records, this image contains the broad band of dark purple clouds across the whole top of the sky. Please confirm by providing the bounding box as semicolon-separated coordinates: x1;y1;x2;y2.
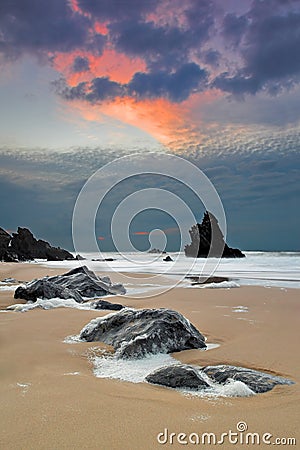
0;0;300;102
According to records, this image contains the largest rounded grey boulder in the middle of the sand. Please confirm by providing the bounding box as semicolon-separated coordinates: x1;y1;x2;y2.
80;308;206;358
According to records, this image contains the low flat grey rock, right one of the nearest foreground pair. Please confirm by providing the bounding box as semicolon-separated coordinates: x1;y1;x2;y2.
201;365;294;394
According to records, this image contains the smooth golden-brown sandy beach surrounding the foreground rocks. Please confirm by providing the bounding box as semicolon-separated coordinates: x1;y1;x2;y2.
0;263;300;450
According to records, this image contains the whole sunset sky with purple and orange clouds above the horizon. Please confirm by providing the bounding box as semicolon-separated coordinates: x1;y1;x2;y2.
0;0;300;250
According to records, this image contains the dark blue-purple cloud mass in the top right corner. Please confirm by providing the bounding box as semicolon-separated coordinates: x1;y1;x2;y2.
213;0;300;95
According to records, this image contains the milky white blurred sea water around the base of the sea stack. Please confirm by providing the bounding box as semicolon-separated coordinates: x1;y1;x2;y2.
42;251;300;291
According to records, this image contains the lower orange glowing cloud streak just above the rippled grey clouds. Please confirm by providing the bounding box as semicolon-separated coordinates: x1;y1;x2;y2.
68;91;218;149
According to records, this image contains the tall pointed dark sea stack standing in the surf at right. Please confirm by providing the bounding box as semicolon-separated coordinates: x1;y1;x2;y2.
184;211;245;258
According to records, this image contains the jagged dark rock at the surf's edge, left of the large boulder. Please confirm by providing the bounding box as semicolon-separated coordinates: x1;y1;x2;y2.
14;266;126;309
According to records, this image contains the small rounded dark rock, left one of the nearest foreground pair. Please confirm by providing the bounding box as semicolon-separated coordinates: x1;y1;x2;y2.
146;364;209;390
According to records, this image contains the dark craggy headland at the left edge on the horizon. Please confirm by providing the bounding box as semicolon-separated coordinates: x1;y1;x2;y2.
0;227;74;262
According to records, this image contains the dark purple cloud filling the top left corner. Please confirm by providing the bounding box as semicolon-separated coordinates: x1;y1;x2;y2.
0;0;96;57
